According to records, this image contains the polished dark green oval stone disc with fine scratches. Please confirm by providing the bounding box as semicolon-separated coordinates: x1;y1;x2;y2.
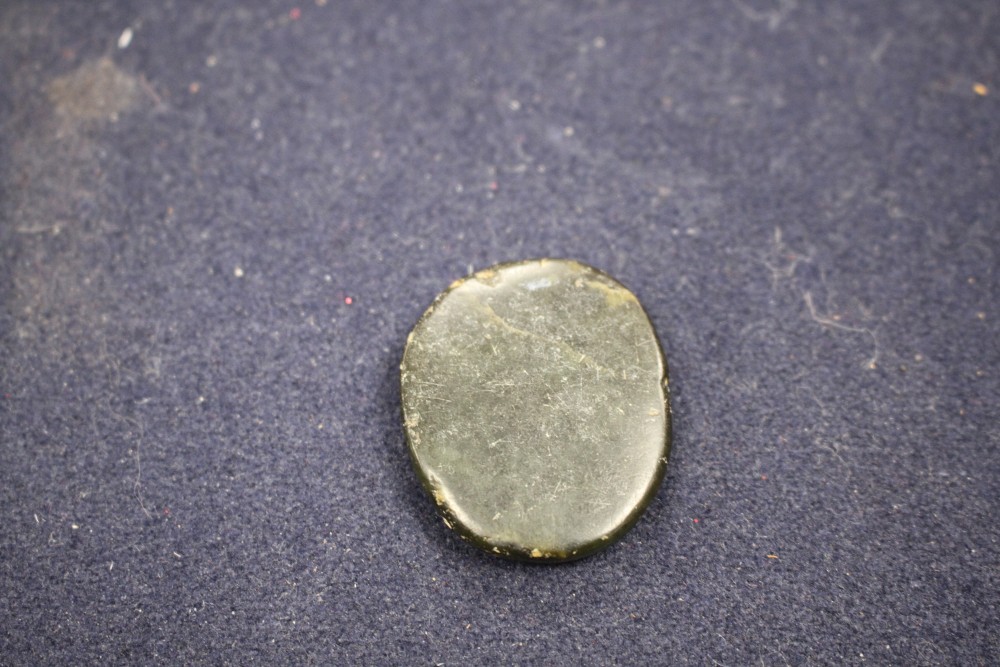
400;259;670;562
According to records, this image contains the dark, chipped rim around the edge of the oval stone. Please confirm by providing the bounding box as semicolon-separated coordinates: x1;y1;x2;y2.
400;257;673;563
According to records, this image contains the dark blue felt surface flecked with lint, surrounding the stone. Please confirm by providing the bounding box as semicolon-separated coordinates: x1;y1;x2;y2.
0;0;1000;665
